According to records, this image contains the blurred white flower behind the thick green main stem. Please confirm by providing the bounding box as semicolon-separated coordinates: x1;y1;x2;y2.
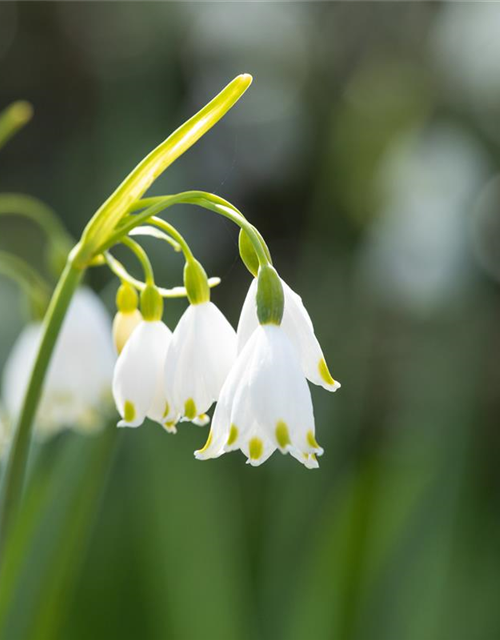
2;287;115;435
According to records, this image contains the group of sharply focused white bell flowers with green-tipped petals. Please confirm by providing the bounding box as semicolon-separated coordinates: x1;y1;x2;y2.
113;267;340;468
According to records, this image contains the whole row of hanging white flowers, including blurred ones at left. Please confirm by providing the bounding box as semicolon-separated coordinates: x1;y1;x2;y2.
2;245;340;468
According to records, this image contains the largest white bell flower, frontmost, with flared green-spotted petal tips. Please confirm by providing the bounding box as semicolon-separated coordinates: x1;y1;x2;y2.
195;324;323;468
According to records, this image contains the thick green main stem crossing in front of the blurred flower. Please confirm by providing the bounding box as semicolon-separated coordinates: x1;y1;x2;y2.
0;259;83;557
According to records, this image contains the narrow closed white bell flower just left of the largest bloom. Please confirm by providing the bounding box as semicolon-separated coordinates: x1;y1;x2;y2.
165;301;236;424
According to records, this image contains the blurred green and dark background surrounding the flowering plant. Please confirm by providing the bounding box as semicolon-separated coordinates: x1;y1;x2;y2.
0;1;500;640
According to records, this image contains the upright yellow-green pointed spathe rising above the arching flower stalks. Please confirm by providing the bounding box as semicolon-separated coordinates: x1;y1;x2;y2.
76;74;252;266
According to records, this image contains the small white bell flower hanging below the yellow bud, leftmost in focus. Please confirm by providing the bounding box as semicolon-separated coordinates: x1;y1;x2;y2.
113;320;177;430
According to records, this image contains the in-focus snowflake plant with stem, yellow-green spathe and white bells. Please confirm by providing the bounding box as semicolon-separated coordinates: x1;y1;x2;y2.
0;74;340;552
